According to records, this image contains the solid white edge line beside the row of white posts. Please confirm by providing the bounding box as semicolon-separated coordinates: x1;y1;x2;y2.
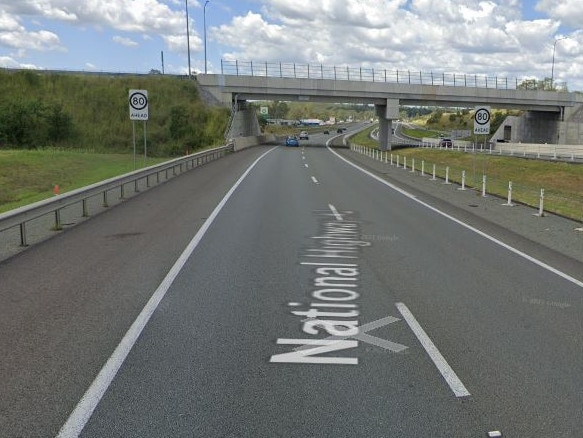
328;147;583;288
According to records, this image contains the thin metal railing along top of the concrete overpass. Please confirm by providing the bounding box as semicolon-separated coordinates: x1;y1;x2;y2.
221;60;563;90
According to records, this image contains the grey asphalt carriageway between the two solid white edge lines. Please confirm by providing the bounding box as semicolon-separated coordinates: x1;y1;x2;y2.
72;148;583;437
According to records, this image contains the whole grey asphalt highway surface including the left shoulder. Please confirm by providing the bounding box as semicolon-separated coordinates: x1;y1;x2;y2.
0;134;583;438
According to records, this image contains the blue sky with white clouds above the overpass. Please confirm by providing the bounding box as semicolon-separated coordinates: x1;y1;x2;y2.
0;0;583;91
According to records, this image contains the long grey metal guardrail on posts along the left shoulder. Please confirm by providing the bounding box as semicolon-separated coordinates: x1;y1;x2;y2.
0;145;233;246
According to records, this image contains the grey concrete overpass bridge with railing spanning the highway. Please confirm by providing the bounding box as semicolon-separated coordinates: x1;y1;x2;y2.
197;61;583;150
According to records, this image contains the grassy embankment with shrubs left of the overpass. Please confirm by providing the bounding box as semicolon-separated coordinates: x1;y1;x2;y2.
0;70;229;156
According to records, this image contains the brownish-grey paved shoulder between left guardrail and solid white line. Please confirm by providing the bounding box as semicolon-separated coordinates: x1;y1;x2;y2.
0;149;270;438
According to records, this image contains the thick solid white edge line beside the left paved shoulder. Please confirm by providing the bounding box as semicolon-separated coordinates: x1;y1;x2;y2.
57;148;275;438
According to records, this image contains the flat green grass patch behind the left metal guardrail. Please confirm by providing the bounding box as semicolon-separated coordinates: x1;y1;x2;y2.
0;149;167;212
